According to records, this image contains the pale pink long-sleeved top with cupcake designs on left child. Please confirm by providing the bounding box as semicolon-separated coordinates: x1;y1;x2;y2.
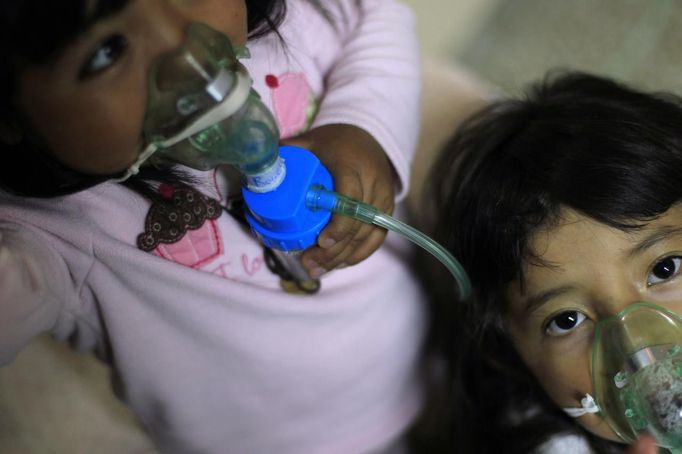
0;0;425;454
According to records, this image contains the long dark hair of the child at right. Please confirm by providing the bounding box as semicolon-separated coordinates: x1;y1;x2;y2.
414;72;682;453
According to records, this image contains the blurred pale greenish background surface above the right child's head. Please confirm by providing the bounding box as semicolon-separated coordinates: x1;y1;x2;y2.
404;0;682;93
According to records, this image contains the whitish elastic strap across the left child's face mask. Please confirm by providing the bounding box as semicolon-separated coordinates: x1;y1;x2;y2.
112;67;251;183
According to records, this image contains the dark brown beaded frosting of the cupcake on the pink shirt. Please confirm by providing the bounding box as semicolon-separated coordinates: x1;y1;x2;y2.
137;184;222;252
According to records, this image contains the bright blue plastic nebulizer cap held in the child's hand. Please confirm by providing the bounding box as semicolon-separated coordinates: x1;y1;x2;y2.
242;145;334;252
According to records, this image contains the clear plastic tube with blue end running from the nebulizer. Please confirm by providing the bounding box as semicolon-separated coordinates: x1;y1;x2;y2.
306;186;471;300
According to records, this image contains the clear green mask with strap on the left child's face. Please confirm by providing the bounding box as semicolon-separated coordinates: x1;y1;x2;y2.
117;23;285;192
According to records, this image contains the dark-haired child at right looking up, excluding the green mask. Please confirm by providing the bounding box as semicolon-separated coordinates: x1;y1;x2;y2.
424;73;682;453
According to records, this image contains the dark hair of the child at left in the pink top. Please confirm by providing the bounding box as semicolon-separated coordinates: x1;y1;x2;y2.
0;0;286;197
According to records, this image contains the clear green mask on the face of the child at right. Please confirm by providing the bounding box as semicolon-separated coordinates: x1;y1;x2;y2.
592;303;682;453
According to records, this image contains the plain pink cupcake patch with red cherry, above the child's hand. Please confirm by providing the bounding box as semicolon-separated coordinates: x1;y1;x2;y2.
265;73;317;138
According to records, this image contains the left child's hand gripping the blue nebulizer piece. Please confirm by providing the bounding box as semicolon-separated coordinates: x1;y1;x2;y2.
284;124;395;278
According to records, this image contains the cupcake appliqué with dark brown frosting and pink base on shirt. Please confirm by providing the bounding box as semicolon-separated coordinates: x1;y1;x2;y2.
137;184;223;268
